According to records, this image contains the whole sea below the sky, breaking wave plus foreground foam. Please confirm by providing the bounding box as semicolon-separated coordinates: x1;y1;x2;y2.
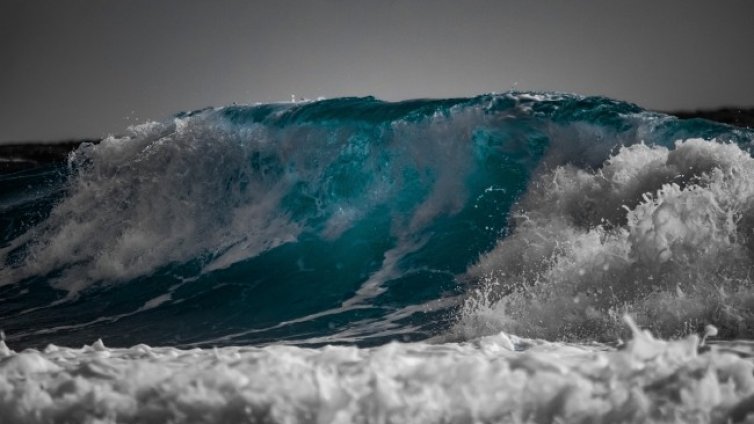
0;92;754;423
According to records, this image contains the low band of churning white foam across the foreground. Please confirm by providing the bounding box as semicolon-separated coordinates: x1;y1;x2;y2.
0;322;754;424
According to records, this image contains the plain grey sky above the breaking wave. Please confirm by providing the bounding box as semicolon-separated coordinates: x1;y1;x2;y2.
0;0;754;142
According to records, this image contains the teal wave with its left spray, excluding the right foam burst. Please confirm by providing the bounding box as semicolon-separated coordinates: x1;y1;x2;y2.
0;93;751;346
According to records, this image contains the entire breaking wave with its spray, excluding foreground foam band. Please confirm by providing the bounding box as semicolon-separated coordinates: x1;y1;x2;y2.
0;93;754;346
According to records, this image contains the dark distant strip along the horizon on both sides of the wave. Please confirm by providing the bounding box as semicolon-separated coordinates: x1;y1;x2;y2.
0;107;754;173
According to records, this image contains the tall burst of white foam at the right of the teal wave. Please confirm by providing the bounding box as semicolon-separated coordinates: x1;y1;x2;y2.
455;140;754;340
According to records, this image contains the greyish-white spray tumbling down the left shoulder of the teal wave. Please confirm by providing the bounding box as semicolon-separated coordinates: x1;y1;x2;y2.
6;117;300;293
